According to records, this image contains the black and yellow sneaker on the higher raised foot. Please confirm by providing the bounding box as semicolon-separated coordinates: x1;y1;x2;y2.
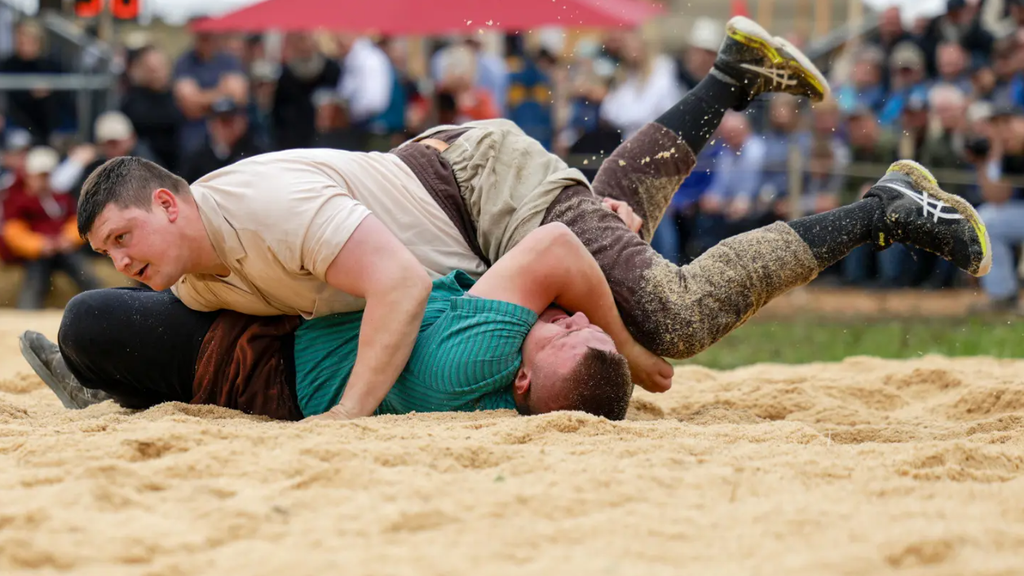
715;16;829;108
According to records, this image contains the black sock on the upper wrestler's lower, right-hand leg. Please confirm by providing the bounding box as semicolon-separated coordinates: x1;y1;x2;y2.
790;198;885;271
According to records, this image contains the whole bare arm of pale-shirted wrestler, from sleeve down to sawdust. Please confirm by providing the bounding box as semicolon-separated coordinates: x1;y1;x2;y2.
317;215;430;419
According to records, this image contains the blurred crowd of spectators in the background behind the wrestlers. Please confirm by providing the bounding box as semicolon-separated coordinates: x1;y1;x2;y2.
0;0;1024;310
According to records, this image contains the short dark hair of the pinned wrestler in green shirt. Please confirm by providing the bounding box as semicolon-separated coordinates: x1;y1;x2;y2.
561;348;633;420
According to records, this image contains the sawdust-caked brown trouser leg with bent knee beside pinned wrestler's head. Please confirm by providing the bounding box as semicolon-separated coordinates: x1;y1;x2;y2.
544;186;818;359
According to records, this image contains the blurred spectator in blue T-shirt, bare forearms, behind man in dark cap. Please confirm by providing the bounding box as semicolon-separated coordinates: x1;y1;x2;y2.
174;33;249;154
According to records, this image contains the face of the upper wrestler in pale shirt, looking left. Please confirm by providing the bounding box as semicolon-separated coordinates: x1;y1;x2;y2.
88;190;188;291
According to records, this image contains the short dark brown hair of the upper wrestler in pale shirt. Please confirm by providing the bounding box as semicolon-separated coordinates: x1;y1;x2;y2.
78;156;191;238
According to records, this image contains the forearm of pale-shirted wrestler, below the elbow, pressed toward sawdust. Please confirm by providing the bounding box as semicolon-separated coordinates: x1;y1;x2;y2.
331;282;430;412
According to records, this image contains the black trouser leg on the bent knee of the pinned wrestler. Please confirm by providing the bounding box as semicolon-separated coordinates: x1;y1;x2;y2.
57;288;219;409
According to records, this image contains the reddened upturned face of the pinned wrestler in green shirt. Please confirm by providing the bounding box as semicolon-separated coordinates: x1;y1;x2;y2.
515;307;616;414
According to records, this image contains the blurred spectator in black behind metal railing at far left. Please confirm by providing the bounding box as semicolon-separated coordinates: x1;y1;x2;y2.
0;20;76;143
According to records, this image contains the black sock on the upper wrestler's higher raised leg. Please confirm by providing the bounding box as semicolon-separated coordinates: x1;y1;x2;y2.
654;69;749;155
